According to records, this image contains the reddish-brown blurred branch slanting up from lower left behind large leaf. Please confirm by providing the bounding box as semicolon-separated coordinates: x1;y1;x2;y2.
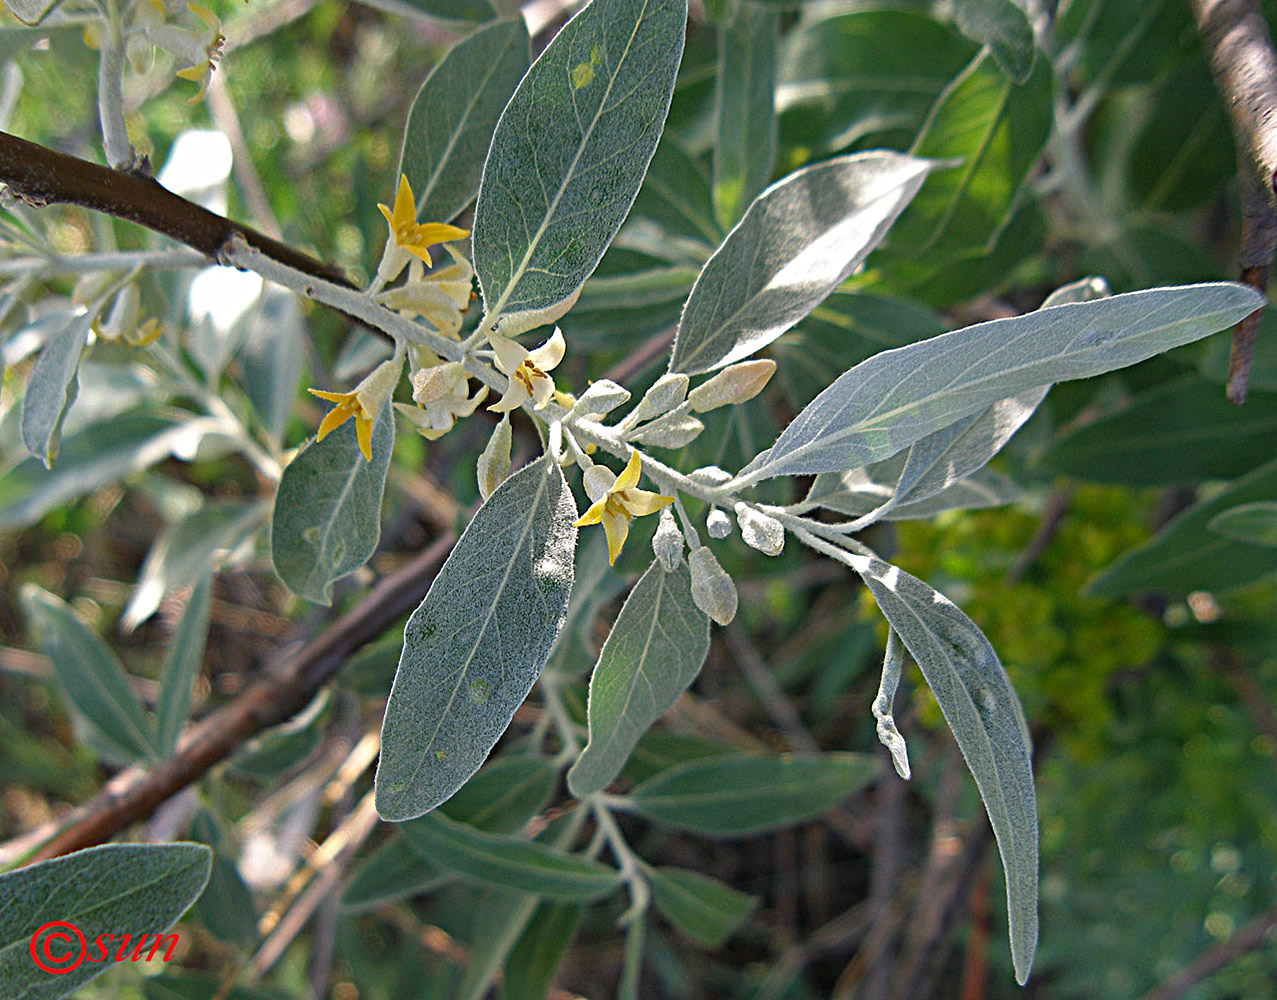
0;534;453;863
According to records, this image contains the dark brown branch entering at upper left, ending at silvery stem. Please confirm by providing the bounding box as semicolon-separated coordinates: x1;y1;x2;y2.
0;132;355;289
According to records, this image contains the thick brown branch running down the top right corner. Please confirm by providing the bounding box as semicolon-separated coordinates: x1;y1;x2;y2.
1189;0;1277;405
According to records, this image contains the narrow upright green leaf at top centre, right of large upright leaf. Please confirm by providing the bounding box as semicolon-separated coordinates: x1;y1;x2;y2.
714;4;779;229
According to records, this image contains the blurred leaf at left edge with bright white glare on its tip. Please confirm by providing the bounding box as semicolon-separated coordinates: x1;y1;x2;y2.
0;410;211;529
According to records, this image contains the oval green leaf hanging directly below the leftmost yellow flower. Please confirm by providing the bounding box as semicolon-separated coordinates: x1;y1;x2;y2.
271;398;395;604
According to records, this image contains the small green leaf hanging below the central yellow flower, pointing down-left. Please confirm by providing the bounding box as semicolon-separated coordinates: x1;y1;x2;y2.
567;562;710;798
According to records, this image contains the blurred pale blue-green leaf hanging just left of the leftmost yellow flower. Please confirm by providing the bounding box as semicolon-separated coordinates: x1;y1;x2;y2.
239;285;303;442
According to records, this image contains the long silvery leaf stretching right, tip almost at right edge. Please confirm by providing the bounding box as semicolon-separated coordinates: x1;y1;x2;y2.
738;282;1260;483
